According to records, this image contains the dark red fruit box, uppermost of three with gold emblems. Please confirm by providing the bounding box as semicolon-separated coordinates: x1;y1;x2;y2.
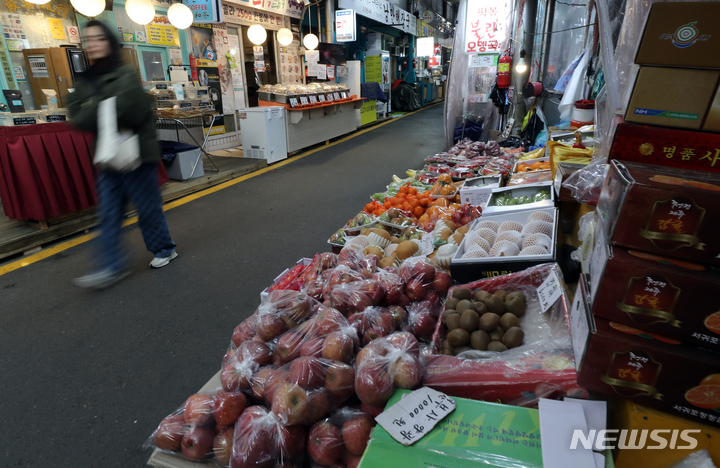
597;161;720;265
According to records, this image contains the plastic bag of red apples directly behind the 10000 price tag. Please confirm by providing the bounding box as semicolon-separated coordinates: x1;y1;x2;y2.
355;332;423;408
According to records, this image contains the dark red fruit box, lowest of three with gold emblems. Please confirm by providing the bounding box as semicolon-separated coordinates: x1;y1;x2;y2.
570;276;720;428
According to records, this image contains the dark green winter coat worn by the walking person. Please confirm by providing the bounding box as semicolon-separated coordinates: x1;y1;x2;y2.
67;65;160;164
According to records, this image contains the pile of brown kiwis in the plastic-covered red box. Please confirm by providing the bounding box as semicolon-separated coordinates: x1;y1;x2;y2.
441;288;527;356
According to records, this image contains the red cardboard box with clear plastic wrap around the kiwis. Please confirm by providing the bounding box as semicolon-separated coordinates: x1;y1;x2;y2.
423;263;583;406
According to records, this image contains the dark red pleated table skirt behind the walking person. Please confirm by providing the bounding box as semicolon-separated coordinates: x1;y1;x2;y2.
0;122;169;220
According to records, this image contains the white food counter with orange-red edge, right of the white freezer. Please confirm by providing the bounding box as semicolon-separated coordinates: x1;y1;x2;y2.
259;97;365;153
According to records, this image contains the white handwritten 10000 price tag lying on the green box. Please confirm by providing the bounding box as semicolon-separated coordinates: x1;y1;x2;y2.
375;387;457;446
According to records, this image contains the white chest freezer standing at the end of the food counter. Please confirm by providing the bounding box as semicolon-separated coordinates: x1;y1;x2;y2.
238;106;287;164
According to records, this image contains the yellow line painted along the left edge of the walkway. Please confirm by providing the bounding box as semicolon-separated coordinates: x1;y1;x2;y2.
0;103;439;276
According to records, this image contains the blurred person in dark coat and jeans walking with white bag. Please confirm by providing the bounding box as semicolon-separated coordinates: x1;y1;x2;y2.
67;21;178;288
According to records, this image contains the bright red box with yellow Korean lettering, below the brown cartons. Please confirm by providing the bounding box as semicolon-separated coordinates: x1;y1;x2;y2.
612;123;720;175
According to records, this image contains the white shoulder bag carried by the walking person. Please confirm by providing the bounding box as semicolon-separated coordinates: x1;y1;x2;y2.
94;96;140;172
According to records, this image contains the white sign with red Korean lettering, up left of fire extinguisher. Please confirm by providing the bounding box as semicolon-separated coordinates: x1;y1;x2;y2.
463;0;508;54
